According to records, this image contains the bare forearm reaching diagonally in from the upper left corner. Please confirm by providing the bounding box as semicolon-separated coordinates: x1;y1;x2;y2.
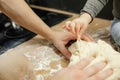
0;0;53;40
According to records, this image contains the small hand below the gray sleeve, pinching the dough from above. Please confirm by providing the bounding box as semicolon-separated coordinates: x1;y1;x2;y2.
65;13;91;37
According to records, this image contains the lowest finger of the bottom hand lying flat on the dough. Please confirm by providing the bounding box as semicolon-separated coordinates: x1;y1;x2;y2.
87;69;113;80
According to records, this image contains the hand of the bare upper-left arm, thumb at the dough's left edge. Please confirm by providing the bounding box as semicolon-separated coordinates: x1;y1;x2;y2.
52;31;76;59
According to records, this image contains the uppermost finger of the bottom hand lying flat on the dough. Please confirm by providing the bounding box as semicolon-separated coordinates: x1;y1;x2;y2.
71;57;94;69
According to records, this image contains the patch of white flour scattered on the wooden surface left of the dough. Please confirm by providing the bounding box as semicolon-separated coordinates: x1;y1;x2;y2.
24;46;63;80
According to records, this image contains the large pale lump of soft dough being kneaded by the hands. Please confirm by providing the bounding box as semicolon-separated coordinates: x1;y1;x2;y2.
69;40;120;80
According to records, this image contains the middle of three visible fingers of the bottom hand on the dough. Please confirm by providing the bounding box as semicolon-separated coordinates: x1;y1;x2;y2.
84;62;106;77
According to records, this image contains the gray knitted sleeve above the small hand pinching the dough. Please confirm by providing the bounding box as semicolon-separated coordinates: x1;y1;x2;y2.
82;0;109;18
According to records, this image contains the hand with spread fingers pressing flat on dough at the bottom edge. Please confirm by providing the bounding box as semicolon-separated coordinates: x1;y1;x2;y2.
52;58;113;80
